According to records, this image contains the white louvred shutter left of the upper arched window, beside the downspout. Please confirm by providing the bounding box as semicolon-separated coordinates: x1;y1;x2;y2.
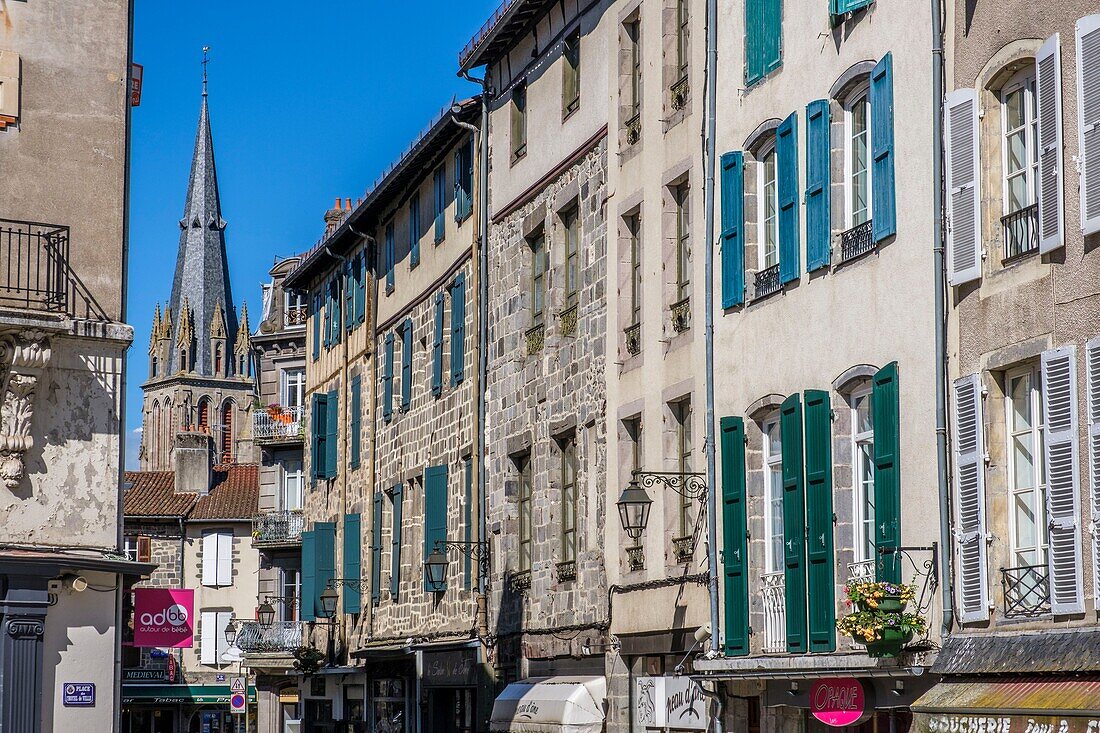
944;89;981;285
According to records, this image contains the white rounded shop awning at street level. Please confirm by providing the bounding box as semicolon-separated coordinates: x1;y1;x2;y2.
490;677;607;733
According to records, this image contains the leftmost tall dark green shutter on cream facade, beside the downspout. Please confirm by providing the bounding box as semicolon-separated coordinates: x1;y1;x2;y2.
719;417;749;656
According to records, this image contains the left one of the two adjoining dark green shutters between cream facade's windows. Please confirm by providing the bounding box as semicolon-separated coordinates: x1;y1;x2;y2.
779;394;807;653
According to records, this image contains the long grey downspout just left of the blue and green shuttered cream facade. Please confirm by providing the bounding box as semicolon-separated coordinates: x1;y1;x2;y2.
703;0;722;656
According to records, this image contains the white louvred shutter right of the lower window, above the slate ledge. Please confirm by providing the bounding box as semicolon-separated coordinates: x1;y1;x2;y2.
1042;346;1085;614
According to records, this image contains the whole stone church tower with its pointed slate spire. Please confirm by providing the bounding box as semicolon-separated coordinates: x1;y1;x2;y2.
141;79;255;471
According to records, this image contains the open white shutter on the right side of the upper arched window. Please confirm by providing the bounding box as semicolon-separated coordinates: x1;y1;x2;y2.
1035;33;1065;252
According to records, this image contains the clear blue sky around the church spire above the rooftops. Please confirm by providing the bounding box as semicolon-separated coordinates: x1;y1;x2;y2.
127;0;499;469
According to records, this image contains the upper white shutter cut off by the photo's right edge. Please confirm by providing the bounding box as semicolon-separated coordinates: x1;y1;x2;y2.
1077;15;1100;236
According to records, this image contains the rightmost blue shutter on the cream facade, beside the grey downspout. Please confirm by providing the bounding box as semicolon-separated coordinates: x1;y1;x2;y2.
868;53;898;242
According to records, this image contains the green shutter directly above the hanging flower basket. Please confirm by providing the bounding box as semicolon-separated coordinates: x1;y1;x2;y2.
871;361;901;583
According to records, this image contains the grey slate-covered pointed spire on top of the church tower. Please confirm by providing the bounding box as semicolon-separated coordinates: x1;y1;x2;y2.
165;84;237;375
